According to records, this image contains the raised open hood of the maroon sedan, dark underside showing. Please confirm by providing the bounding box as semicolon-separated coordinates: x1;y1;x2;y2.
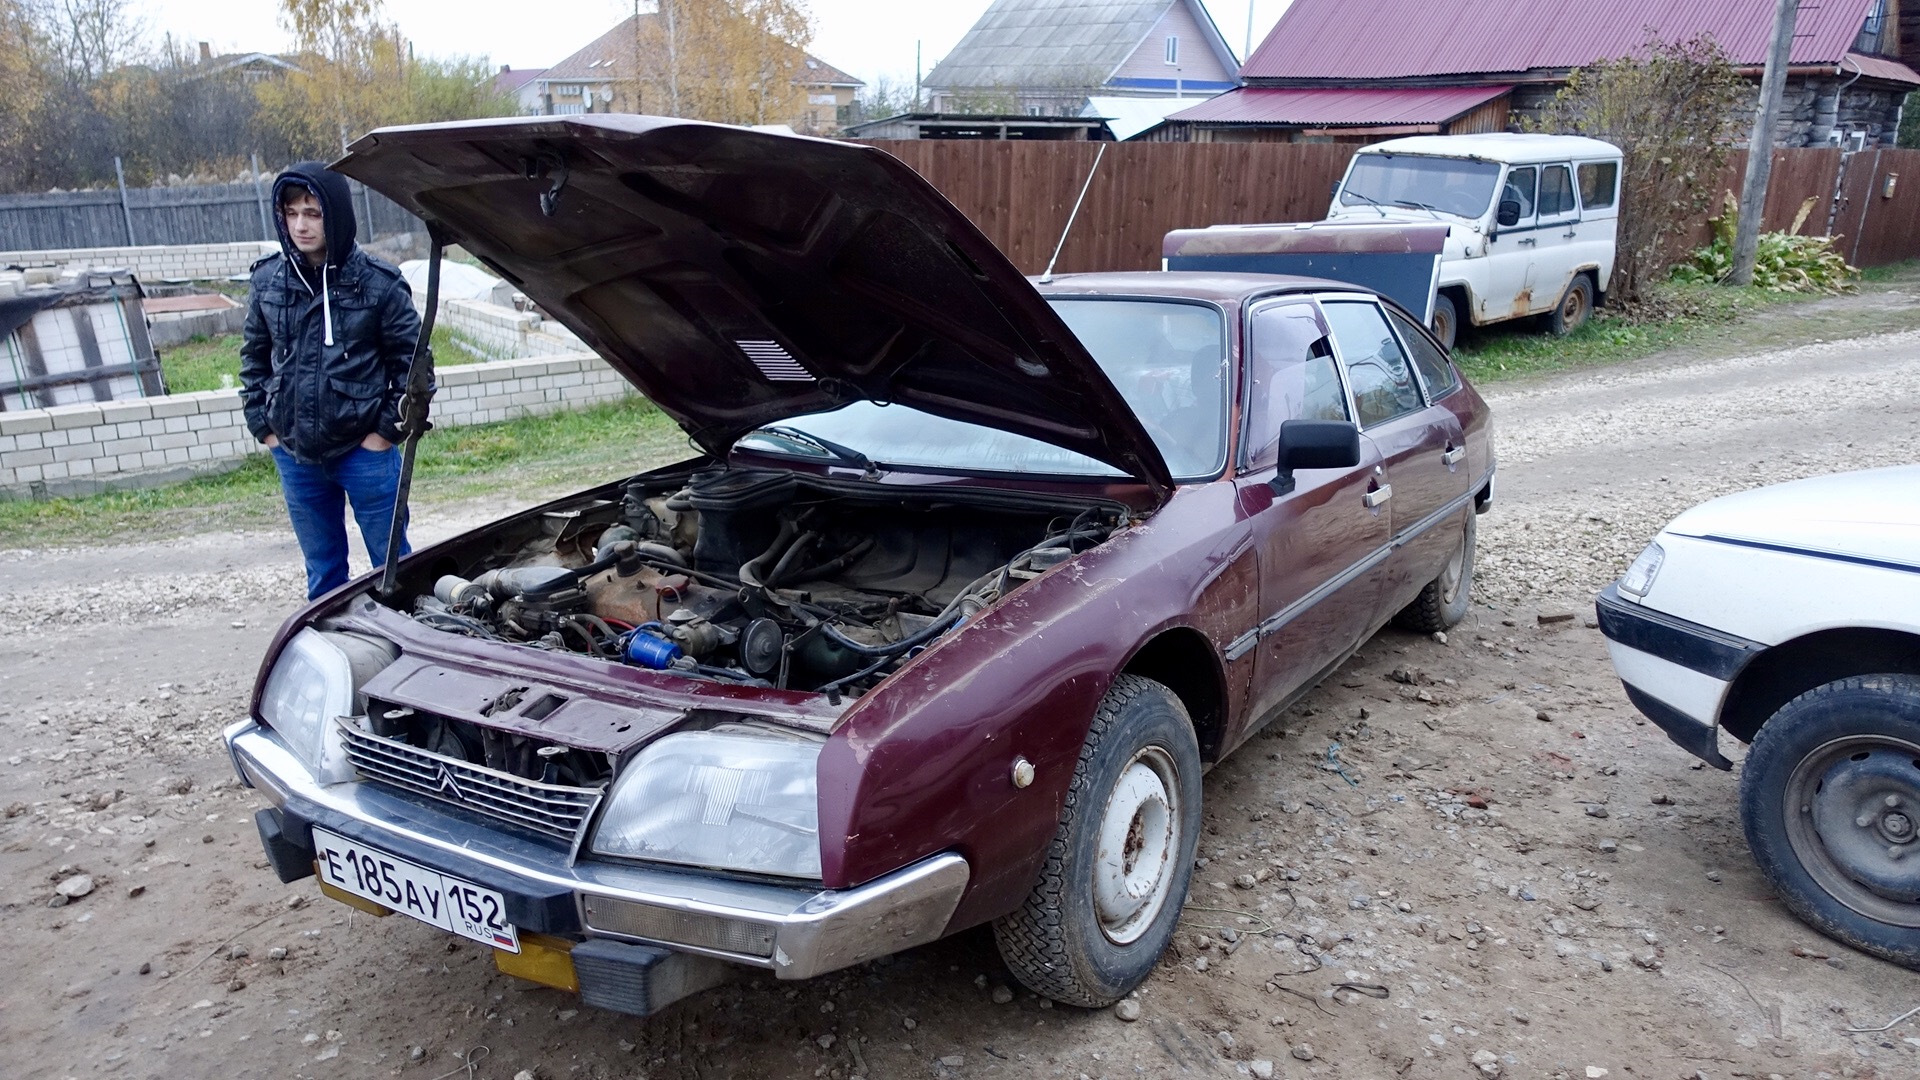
334;113;1171;498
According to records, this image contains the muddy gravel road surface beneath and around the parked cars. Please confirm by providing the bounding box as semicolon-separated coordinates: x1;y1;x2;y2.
0;298;1920;1080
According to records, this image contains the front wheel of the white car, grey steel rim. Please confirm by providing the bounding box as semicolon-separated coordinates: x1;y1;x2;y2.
1740;675;1920;969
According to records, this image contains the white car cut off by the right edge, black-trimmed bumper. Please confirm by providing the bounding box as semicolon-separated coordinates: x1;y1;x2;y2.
1597;465;1920;969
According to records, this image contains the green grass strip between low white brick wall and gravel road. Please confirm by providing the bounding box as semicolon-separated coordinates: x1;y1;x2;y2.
0;398;691;548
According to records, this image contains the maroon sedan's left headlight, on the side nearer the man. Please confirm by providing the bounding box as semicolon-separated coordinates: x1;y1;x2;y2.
259;630;396;771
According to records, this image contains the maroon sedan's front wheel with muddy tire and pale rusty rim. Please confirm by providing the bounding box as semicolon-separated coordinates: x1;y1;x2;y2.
993;675;1200;1009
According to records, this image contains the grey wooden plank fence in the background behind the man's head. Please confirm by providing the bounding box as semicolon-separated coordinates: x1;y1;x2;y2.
0;181;426;252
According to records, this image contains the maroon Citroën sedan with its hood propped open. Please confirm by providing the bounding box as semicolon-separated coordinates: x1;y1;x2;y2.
227;115;1494;1015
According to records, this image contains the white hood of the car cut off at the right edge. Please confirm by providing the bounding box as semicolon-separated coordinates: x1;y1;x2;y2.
1667;465;1920;567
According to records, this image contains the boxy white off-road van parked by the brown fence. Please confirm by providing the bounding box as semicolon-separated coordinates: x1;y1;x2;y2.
1327;135;1620;348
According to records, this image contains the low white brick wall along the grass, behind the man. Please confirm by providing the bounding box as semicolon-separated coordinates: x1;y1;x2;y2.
0;354;634;498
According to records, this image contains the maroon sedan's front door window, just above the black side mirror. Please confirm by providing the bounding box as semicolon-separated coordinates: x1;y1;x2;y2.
1246;302;1350;469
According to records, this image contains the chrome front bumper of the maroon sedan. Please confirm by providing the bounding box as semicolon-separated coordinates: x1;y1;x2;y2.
225;721;970;978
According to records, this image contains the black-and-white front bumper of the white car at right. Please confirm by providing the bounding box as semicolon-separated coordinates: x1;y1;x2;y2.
1594;584;1766;769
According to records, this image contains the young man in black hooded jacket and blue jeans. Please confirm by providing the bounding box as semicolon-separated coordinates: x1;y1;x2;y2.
240;161;420;600
